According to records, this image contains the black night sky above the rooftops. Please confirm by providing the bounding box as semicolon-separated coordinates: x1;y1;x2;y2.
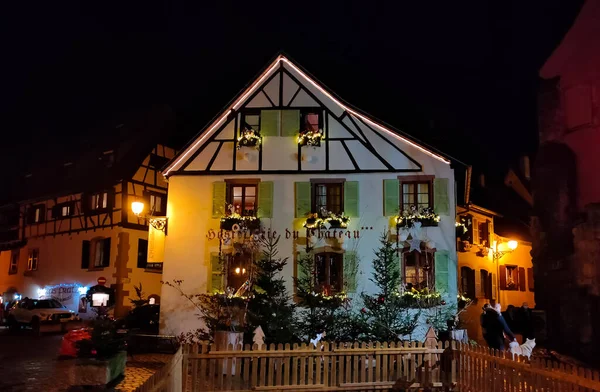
0;0;582;182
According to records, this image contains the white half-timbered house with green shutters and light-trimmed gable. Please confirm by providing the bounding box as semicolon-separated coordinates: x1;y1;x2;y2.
161;56;462;334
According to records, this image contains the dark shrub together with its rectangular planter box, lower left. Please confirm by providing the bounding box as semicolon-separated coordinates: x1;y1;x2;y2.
70;320;127;386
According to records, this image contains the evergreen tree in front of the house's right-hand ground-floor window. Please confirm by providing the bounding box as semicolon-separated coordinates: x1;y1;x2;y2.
361;233;420;341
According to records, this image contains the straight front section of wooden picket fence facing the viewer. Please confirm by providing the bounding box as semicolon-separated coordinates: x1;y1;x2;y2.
183;342;457;392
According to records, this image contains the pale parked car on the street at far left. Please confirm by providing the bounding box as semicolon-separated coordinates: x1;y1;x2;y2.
7;298;75;334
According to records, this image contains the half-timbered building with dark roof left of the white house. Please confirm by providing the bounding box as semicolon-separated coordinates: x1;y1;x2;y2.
0;108;175;318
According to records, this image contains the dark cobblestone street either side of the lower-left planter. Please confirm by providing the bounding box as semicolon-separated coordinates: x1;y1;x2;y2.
0;327;170;392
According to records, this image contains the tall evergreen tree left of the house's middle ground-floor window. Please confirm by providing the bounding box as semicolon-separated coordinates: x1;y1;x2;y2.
246;236;295;344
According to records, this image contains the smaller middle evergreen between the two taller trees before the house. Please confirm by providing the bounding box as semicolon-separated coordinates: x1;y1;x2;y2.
295;245;345;340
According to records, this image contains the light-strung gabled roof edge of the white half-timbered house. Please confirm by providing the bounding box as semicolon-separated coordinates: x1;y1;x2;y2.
163;54;464;176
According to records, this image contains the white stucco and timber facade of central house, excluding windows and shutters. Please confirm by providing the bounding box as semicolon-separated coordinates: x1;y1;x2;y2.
161;56;457;335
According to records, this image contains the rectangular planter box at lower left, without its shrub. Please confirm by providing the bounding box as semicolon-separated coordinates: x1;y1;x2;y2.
69;351;127;386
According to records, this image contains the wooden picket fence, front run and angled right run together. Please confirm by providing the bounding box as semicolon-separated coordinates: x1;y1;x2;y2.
182;342;600;392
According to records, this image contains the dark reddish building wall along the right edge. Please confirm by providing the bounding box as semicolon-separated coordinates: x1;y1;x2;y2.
532;1;600;362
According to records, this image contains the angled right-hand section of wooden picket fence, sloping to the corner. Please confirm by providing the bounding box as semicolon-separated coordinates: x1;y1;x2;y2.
457;344;600;392
